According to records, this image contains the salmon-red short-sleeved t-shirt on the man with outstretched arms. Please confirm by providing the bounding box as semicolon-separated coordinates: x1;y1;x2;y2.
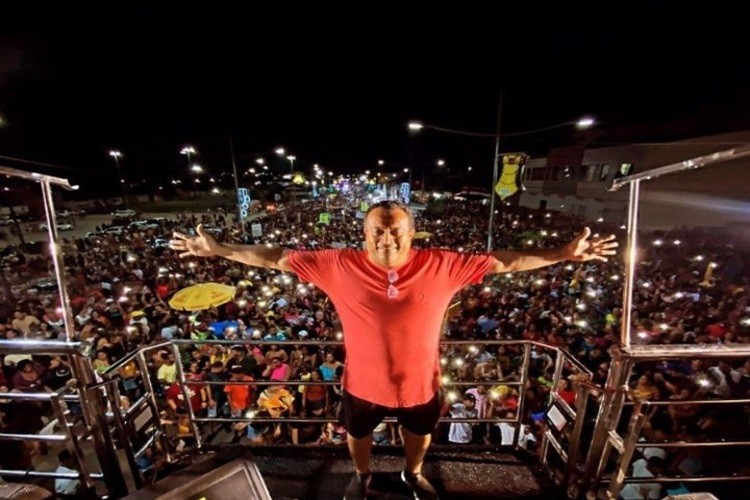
287;249;495;408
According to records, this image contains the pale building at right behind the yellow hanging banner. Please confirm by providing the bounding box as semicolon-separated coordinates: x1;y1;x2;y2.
519;131;750;228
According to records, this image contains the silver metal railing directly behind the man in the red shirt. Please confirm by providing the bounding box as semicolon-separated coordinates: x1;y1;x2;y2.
92;340;593;494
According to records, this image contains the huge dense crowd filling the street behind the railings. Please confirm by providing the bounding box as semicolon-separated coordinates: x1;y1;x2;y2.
0;189;750;495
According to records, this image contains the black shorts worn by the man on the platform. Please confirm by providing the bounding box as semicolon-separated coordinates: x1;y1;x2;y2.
341;391;440;439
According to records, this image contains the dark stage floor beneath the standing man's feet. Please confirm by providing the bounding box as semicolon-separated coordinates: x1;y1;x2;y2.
127;445;564;500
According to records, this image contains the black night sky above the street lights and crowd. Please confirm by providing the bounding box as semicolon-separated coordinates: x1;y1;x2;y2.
0;2;750;193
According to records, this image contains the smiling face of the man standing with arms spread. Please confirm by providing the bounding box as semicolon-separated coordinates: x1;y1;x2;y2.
365;208;414;267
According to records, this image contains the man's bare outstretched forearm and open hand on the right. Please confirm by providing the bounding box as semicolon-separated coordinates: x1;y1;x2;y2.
490;228;617;273
